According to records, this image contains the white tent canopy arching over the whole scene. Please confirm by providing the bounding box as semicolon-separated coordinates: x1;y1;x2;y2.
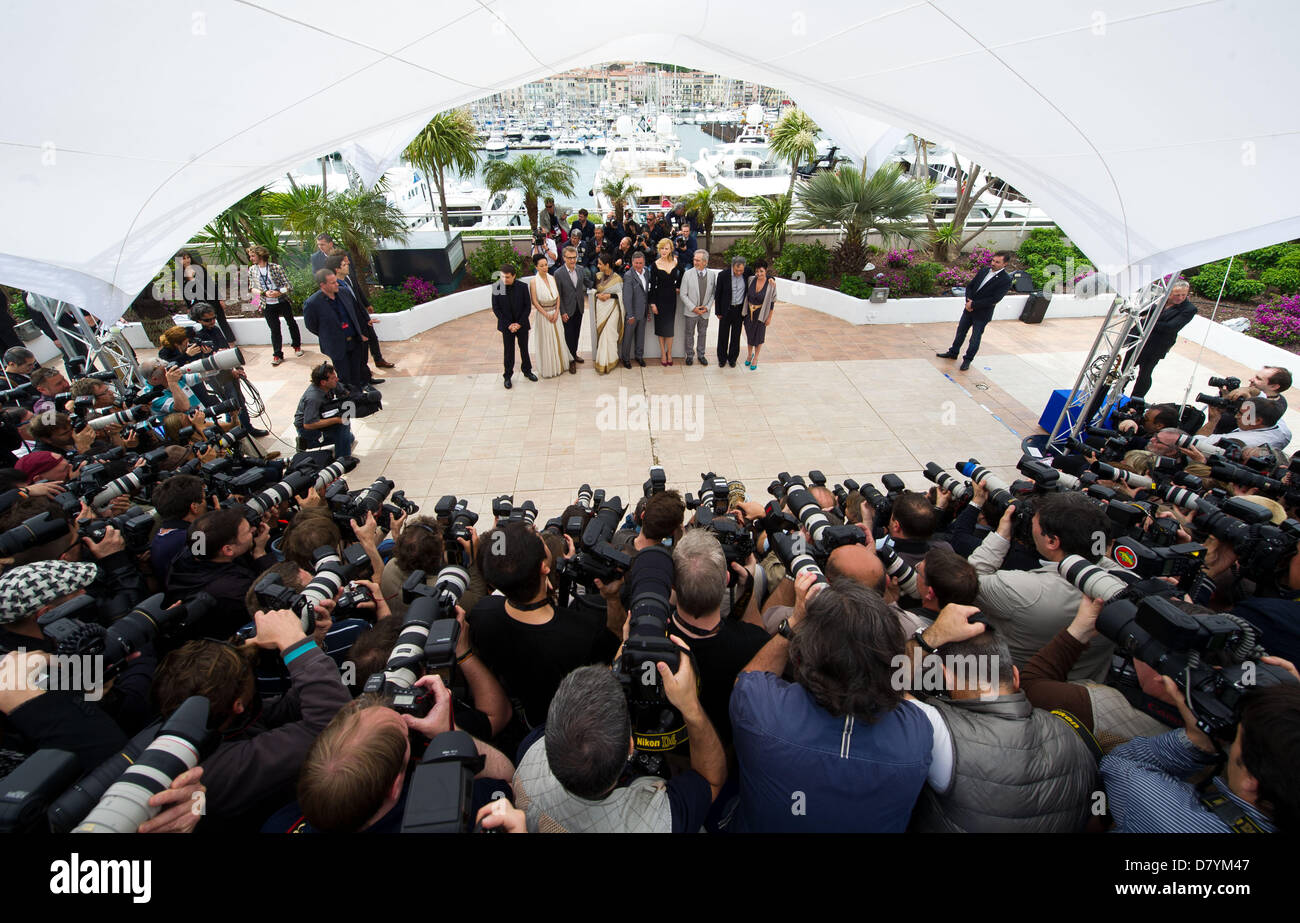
0;0;1300;320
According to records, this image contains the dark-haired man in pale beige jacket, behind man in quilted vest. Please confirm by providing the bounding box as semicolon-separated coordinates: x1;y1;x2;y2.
969;485;1114;683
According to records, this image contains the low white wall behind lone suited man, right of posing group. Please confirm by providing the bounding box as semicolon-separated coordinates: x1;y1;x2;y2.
776;278;1113;324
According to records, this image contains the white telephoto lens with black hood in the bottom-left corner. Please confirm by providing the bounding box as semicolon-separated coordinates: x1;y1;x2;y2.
73;696;220;833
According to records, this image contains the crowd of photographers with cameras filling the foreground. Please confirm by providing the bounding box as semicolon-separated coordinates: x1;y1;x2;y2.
0;352;1300;832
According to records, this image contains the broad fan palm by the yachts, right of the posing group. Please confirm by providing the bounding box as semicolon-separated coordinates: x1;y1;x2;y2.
800;164;935;273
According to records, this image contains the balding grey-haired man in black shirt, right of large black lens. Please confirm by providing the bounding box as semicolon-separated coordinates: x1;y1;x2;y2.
668;529;770;746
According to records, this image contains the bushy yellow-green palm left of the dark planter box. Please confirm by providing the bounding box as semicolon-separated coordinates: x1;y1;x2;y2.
268;179;407;285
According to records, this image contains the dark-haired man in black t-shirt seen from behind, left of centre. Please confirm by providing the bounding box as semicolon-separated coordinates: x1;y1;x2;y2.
468;523;619;727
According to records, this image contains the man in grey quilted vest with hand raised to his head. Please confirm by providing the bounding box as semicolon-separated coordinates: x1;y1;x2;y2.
907;605;1097;833
